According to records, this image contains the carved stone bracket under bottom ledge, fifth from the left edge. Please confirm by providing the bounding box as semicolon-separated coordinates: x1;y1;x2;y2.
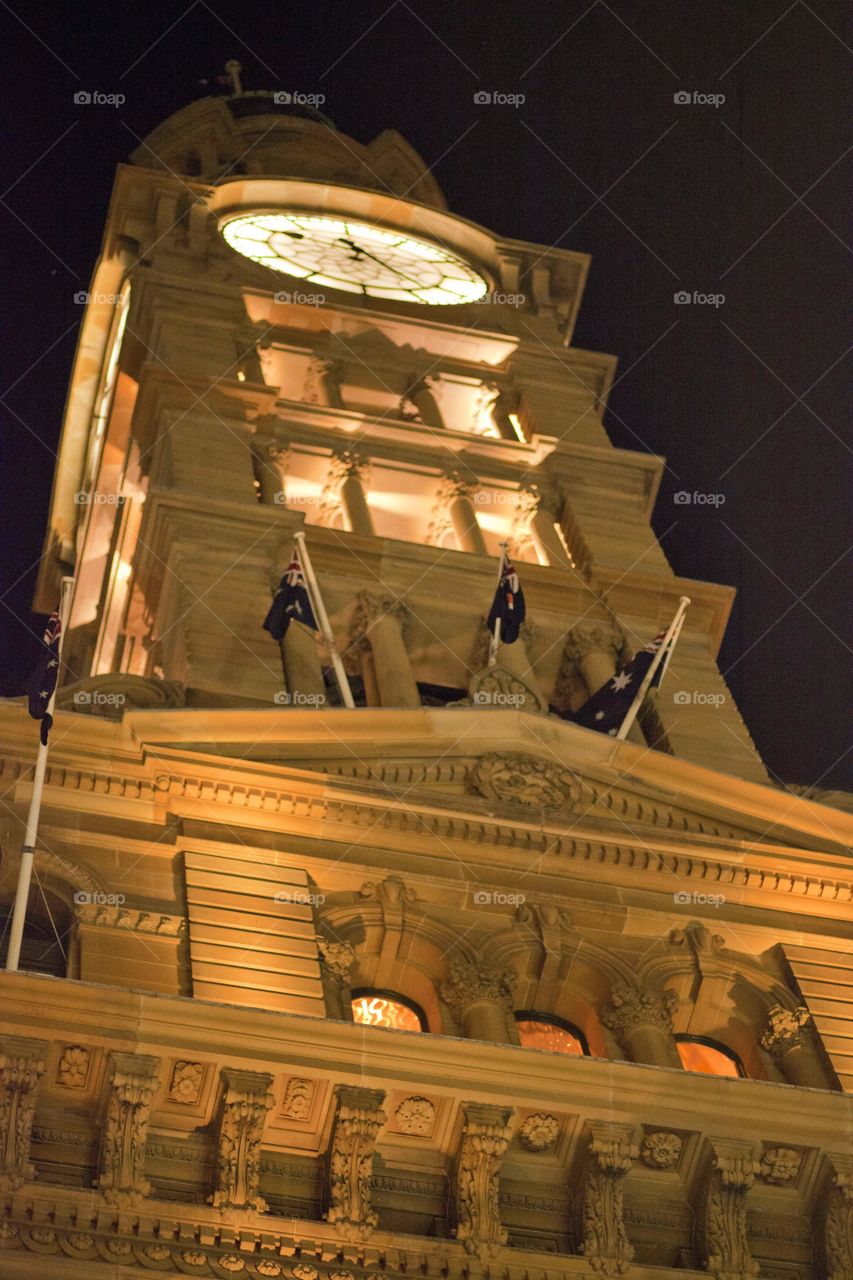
453;1102;512;1262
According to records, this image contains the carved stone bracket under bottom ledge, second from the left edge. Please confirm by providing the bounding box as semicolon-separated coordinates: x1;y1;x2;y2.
97;1053;160;1206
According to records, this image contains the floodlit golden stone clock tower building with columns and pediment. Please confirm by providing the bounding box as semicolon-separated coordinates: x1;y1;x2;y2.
0;80;853;1280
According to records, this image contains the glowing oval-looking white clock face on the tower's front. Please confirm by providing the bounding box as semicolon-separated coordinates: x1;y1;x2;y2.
222;212;488;306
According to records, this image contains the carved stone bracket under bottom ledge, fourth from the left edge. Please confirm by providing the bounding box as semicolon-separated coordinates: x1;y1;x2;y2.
325;1084;387;1240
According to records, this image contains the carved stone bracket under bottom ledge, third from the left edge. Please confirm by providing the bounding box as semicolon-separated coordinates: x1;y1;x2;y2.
210;1068;274;1213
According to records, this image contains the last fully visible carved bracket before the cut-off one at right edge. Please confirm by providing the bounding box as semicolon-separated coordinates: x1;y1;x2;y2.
697;1138;760;1280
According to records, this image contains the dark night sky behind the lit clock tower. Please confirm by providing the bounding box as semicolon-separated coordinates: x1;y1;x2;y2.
0;0;850;787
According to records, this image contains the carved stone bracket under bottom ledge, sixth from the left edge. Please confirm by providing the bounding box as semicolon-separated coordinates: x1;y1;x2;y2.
580;1120;639;1276
